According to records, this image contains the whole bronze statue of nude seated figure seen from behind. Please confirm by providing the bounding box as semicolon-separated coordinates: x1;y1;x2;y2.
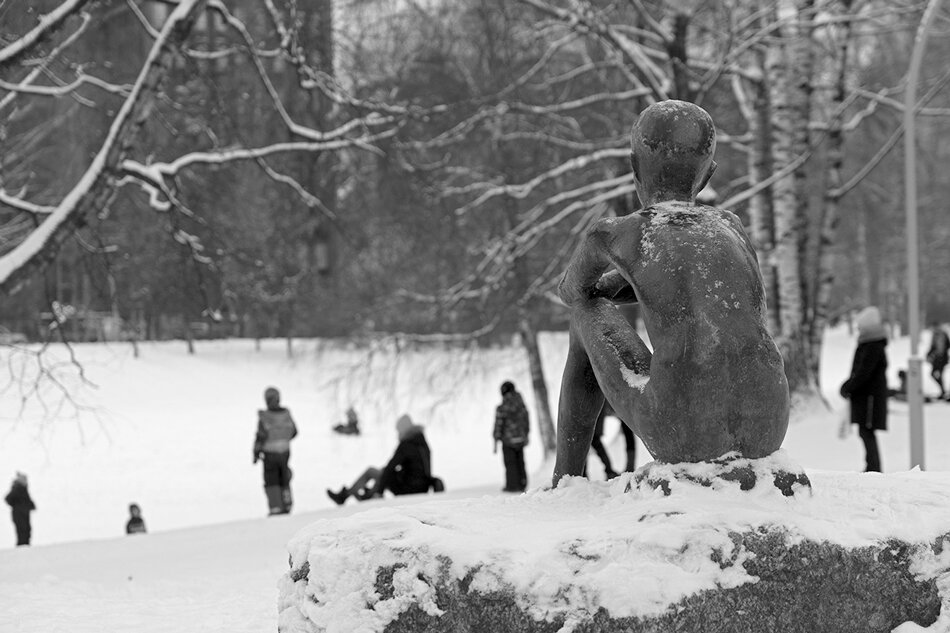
554;100;789;485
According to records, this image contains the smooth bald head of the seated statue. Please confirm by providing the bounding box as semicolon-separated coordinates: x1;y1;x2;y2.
630;99;716;205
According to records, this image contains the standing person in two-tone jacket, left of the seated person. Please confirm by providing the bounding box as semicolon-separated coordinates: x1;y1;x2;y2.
254;387;297;515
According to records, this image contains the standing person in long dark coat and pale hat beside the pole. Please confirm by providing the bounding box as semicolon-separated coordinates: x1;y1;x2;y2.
841;306;888;472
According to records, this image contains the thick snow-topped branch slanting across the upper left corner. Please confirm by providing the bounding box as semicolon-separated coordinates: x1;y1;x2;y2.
0;0;204;291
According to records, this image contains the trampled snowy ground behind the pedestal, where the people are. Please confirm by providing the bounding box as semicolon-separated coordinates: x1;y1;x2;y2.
0;329;950;633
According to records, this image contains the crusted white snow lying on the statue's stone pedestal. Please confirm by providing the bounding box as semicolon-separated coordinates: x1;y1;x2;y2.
280;451;950;633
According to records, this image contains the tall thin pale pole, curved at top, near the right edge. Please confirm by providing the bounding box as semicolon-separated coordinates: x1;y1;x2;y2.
904;0;941;470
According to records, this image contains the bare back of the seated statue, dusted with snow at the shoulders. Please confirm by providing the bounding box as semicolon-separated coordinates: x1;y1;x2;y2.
602;202;788;461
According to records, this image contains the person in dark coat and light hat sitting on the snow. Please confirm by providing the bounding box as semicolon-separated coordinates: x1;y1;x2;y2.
327;414;434;505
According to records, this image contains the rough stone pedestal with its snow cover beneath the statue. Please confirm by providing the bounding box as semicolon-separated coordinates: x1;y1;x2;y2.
279;454;950;633
